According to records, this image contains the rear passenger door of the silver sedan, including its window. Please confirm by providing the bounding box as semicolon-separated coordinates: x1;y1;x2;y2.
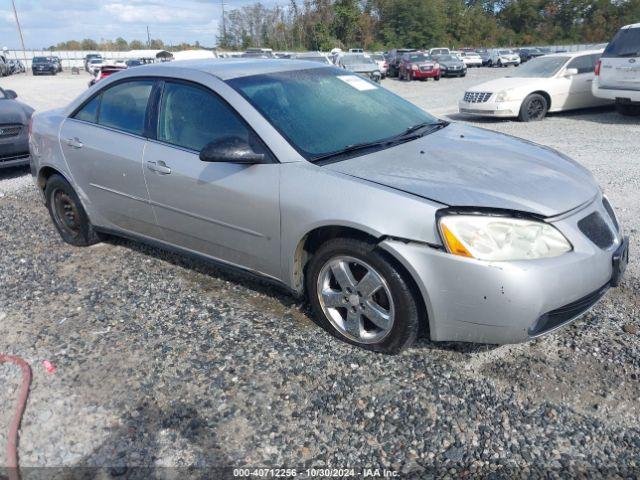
60;79;159;238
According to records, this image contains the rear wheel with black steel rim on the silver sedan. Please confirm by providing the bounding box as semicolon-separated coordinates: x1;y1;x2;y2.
44;175;102;247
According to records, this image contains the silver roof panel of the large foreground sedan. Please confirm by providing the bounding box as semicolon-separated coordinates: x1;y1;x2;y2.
143;58;332;80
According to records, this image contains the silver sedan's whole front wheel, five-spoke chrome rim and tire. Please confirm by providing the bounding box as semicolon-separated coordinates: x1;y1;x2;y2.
305;238;420;354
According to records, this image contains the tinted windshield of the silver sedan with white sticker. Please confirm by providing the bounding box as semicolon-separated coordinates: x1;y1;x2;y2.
227;68;441;161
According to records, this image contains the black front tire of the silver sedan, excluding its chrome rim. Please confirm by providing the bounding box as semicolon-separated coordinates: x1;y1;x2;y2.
305;238;420;354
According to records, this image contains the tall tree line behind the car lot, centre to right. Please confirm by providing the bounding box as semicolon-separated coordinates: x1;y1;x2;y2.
219;0;640;51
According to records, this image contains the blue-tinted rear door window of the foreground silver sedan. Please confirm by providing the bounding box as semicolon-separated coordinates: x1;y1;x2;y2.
98;80;154;135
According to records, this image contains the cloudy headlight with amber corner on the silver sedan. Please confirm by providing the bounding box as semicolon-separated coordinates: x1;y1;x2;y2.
439;215;572;261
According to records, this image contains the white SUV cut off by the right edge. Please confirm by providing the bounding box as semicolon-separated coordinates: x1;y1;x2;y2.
591;23;640;115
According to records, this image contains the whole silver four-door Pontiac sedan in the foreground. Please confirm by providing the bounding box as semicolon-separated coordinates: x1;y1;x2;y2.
30;60;628;353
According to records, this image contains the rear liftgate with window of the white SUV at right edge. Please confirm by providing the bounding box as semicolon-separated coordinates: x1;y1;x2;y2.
598;27;640;91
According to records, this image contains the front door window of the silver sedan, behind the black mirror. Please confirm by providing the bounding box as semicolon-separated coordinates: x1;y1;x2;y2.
158;82;262;152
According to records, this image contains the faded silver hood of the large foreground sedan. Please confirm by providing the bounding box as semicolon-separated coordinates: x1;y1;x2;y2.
324;124;599;216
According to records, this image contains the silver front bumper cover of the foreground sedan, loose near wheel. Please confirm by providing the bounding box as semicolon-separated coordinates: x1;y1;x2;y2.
381;197;625;344
